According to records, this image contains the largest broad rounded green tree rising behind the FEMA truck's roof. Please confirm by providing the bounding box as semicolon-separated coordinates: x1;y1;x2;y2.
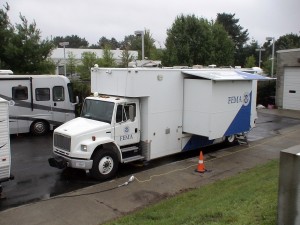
163;15;234;66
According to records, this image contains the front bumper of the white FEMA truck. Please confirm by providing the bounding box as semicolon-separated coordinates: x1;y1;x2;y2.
48;156;93;170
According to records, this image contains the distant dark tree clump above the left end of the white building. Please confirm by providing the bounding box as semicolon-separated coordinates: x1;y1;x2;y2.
53;35;89;48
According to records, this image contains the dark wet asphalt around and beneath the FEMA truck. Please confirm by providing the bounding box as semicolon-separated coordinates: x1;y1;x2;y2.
0;113;300;211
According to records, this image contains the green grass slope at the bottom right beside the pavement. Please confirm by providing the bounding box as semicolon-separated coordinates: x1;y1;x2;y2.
106;160;279;225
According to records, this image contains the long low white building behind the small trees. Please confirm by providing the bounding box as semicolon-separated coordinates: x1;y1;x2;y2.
50;48;138;75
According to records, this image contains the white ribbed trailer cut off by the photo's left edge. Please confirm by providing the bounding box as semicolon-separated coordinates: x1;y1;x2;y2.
0;98;13;194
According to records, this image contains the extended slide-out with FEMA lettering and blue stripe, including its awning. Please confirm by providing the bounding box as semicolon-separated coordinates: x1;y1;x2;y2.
183;69;268;140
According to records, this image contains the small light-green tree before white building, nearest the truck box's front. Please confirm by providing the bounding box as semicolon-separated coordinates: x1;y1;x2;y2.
77;52;100;80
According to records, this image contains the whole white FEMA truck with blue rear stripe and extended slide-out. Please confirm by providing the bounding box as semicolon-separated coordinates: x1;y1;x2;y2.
49;67;266;179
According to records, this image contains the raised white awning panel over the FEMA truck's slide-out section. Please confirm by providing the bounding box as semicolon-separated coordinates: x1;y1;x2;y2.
182;69;272;81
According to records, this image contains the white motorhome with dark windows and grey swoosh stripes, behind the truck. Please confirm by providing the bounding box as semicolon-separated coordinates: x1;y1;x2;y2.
0;75;76;135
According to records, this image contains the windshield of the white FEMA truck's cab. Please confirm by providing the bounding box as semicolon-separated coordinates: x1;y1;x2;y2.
81;99;115;123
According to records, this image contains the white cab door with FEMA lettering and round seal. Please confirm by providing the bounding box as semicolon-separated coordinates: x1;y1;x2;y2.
114;103;140;146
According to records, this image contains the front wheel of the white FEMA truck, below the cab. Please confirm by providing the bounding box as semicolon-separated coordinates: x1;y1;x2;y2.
90;149;119;180
